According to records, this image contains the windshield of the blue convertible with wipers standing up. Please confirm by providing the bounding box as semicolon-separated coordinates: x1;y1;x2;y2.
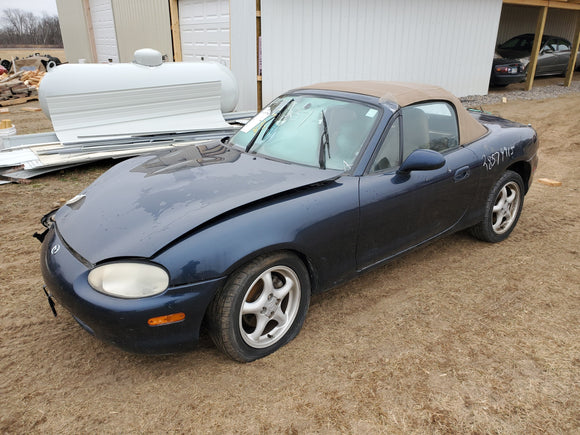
231;95;379;171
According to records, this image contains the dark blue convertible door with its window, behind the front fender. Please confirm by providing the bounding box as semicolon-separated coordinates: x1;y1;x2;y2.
357;103;479;270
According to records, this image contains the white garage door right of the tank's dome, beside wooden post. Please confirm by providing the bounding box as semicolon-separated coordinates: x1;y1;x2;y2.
179;0;230;67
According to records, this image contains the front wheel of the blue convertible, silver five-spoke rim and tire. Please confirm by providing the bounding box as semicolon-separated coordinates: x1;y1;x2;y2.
207;252;310;362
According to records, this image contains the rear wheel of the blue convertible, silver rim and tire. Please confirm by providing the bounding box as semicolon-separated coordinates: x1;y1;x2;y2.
471;171;524;243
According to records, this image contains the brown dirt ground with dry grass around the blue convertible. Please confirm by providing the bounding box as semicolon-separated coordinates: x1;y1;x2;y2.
0;90;580;434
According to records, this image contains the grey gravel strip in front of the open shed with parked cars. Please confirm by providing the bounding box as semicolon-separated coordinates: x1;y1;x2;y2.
460;73;580;107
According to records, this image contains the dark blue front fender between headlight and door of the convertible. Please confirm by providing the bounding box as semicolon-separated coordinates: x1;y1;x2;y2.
154;177;358;291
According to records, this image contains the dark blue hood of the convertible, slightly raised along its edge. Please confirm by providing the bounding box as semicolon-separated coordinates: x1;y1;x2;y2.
54;142;341;264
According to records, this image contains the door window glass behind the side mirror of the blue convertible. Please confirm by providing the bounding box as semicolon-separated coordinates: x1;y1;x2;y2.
402;101;459;160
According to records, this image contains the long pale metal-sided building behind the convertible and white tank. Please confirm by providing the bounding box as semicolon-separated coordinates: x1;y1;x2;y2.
57;0;580;110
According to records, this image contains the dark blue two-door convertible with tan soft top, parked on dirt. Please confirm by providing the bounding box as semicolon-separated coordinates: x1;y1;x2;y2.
40;82;538;361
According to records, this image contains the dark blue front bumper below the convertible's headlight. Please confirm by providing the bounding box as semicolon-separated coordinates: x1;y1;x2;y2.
41;226;225;353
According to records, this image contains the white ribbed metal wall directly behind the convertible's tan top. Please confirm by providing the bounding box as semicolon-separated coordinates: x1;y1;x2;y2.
262;0;502;103
